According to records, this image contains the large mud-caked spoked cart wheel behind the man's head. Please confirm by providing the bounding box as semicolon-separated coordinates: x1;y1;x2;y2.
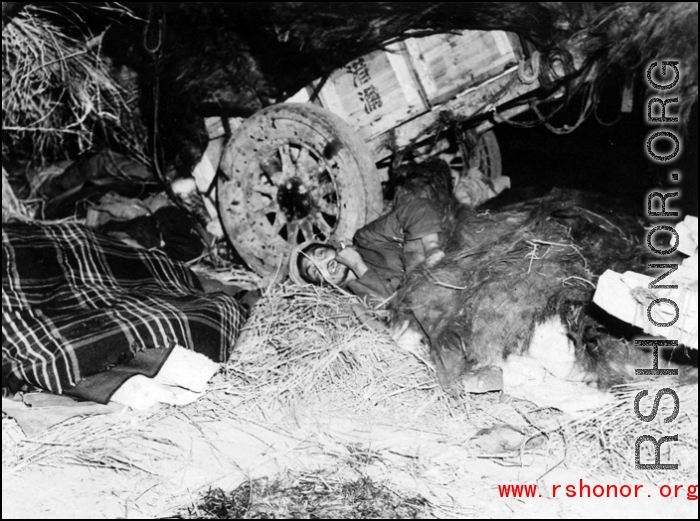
218;103;382;277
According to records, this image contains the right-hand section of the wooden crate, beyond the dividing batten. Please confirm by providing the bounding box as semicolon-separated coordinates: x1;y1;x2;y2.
405;31;518;106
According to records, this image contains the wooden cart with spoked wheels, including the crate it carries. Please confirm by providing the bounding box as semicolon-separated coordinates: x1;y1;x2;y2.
218;31;539;276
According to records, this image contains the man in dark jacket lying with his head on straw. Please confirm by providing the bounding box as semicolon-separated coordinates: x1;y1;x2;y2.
289;193;503;393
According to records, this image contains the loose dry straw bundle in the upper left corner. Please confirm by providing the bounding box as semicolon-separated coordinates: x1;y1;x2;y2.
2;6;146;166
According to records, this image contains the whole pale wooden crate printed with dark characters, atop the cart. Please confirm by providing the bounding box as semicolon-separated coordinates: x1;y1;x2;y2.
288;31;521;142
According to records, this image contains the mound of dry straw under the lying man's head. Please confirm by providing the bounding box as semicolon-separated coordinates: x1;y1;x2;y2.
219;284;434;412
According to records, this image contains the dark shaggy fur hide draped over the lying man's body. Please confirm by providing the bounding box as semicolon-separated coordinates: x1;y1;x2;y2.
393;179;645;389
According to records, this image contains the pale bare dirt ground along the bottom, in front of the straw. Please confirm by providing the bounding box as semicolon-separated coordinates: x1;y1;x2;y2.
2;411;697;519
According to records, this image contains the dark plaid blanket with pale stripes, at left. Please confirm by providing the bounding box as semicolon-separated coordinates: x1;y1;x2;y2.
2;223;245;403
